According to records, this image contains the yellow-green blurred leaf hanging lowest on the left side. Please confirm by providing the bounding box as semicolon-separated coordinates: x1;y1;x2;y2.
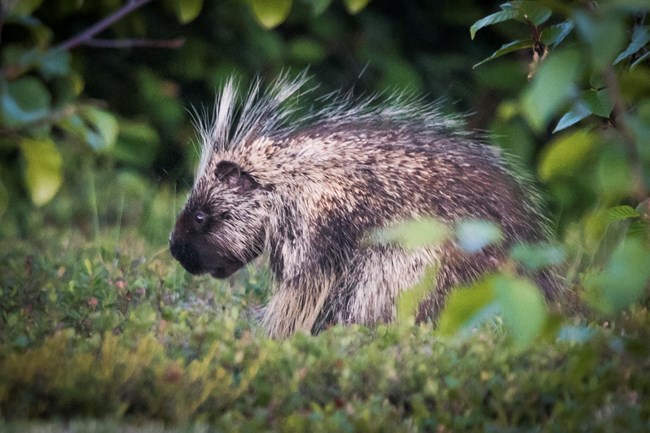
19;137;63;206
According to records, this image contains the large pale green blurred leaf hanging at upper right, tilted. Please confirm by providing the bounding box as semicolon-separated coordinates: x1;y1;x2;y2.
522;50;581;131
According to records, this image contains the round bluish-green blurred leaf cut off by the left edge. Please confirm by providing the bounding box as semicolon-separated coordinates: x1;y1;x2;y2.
0;77;52;127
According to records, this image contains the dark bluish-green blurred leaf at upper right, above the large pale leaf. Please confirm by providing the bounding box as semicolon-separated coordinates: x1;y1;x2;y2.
574;11;625;71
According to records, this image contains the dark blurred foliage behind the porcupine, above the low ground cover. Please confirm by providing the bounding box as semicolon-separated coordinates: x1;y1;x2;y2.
0;0;650;304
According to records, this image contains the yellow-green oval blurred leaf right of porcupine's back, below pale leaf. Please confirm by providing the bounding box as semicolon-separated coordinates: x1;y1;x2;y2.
539;130;598;182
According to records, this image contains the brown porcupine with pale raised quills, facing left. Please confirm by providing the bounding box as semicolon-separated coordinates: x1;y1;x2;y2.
170;74;561;338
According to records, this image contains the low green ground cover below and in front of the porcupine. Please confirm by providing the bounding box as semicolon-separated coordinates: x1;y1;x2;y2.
0;167;650;433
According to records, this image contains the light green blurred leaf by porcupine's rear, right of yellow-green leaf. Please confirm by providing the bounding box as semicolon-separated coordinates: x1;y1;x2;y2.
493;275;547;349
